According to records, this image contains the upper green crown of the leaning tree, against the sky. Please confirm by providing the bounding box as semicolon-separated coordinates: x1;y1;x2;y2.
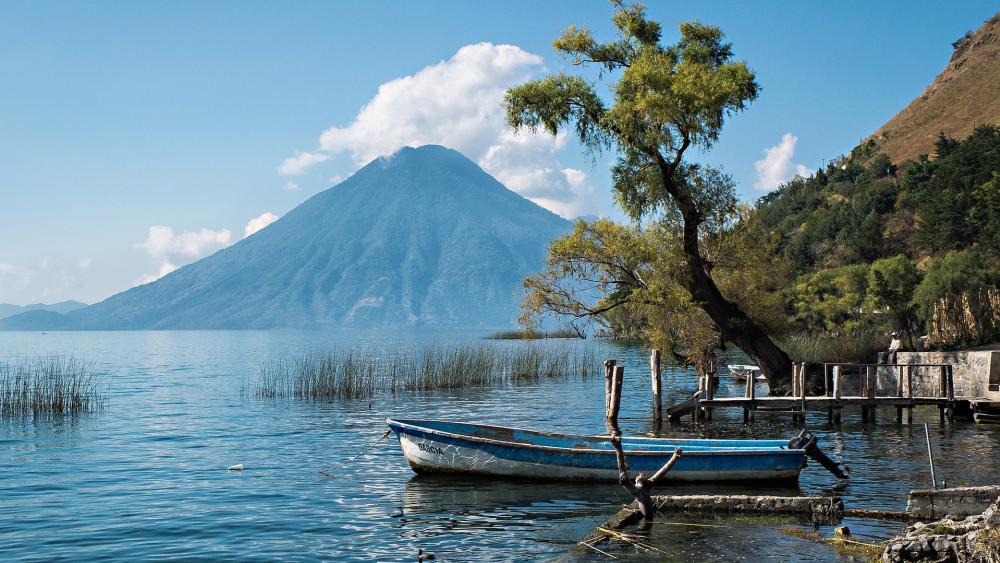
505;2;758;225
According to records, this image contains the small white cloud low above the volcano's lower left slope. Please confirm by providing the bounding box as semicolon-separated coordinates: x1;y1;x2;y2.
133;225;232;285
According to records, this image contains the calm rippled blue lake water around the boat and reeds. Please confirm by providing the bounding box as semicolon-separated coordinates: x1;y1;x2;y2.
0;331;1000;561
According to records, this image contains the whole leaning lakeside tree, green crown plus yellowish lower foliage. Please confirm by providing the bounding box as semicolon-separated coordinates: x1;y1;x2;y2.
505;1;788;372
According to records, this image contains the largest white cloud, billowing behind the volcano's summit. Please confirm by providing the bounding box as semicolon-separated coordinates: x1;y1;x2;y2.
282;43;593;218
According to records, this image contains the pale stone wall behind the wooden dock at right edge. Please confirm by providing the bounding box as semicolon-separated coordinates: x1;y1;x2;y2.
896;351;1000;400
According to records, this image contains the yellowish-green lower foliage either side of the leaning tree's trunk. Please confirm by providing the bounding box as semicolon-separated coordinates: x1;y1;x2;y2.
522;212;791;361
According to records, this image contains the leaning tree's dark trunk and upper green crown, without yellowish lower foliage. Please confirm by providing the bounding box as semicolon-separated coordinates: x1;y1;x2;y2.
505;1;791;389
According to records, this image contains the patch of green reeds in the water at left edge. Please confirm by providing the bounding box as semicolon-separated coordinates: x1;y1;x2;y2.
0;357;107;419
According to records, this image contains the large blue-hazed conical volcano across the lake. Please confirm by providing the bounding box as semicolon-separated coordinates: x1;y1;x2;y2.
6;145;569;330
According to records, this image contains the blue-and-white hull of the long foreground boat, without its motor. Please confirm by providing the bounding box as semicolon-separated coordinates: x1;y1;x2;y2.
389;421;805;481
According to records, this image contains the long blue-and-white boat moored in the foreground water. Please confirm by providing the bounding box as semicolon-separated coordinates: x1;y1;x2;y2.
386;418;833;481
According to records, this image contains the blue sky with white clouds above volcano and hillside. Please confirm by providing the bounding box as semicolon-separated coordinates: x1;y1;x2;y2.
0;0;997;304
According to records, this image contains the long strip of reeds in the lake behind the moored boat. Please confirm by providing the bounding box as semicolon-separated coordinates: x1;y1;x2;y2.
243;345;601;399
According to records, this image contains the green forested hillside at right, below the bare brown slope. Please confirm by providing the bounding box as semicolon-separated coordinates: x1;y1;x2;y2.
757;125;1000;346
